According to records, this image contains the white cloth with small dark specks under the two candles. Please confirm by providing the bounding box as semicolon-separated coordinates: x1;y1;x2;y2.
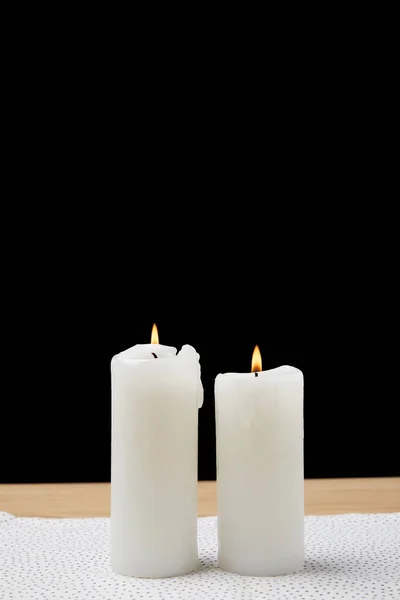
0;513;400;600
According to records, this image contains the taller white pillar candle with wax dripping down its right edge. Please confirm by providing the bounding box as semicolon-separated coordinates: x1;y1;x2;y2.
111;326;203;578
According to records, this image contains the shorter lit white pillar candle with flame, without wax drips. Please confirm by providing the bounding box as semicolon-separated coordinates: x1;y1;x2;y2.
215;347;304;576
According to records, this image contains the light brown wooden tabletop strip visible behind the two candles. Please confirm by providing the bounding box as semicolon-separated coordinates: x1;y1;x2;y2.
0;477;400;517
